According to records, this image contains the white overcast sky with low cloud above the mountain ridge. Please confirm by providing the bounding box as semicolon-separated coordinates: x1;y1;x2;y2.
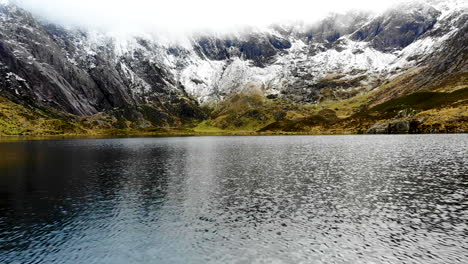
12;0;399;33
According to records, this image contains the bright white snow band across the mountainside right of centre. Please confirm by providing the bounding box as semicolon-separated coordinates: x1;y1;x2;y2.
124;1;466;102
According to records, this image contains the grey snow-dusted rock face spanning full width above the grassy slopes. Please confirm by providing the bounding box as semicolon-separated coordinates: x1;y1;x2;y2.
0;0;468;129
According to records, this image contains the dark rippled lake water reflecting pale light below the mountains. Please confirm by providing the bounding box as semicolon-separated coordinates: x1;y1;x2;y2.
0;135;468;264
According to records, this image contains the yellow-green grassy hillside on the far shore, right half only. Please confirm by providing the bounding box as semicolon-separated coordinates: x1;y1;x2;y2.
195;69;468;134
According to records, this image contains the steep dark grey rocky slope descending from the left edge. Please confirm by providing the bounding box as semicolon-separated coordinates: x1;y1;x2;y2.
0;2;202;129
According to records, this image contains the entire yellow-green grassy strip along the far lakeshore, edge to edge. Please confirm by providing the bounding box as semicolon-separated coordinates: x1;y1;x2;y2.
0;71;468;136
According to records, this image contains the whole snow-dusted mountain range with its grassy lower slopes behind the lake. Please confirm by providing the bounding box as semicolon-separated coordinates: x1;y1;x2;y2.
0;0;468;134
